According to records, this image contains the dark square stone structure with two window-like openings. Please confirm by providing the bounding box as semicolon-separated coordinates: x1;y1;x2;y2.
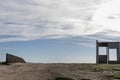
96;40;120;64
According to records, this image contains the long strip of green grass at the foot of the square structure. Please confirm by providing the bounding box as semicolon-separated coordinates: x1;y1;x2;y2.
70;64;120;71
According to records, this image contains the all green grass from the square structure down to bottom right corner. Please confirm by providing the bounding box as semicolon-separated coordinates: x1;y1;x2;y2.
75;64;120;79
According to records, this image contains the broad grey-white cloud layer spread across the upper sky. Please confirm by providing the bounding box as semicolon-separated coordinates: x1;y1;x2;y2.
0;0;119;42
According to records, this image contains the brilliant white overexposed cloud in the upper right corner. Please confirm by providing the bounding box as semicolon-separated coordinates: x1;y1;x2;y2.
92;0;120;32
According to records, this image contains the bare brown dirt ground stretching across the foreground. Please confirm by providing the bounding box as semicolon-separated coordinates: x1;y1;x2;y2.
0;63;120;80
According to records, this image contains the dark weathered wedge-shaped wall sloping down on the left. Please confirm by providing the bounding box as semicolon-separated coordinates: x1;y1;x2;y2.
6;54;25;63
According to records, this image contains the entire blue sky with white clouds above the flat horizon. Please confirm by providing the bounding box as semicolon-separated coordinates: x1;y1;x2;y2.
0;0;120;63
